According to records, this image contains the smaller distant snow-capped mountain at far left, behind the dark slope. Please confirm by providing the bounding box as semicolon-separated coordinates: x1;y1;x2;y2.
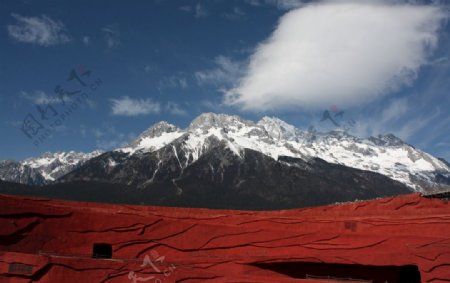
0;150;102;185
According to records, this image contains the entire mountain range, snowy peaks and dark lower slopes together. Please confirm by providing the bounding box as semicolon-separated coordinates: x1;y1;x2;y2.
0;113;450;209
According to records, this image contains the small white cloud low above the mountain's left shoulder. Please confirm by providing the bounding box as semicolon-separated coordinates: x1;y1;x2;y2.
109;96;161;116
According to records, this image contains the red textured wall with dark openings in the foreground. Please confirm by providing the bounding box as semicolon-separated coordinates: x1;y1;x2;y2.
0;194;450;283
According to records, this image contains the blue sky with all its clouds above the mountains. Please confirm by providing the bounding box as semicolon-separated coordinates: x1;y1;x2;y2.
0;0;450;160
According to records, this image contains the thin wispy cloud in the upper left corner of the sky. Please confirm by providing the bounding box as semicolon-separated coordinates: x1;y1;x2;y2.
7;14;70;46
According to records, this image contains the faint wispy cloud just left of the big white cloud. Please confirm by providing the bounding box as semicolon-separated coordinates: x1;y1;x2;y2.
195;55;243;85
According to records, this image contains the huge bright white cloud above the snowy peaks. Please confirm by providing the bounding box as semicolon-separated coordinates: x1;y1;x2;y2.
224;1;447;111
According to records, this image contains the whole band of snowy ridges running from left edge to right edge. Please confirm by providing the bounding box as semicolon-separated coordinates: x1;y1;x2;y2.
0;113;450;193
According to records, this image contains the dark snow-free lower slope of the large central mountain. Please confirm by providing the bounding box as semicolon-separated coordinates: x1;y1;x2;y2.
29;142;410;210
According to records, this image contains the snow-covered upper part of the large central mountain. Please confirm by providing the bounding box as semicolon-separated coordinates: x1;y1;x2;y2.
107;113;450;195
